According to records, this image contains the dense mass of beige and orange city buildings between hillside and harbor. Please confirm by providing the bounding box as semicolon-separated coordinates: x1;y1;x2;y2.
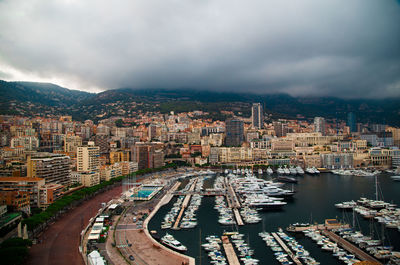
0;100;400;264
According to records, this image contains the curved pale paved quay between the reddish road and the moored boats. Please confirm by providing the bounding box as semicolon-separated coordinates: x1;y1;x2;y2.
82;170;195;265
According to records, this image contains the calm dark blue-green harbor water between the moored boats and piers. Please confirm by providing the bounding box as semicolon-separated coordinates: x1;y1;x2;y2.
149;173;400;265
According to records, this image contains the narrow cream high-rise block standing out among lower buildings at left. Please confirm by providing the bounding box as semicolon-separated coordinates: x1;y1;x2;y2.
77;142;100;172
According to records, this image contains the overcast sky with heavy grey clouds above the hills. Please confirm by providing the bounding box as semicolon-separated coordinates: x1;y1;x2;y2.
0;0;400;98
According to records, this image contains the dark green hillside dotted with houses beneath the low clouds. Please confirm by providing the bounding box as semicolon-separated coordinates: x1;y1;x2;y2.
0;80;400;126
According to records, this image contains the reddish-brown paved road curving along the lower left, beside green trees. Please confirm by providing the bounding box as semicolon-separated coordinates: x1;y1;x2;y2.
27;186;122;265
